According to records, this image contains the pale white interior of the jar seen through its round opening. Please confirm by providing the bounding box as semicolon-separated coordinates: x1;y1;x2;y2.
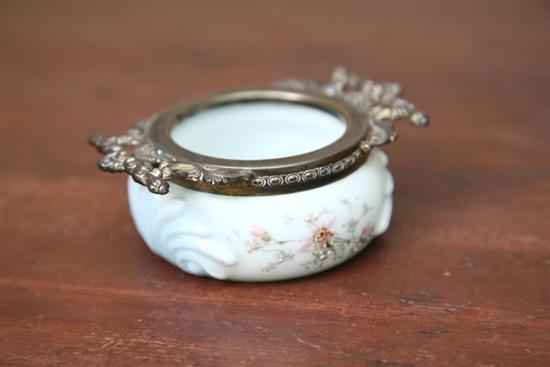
171;101;346;160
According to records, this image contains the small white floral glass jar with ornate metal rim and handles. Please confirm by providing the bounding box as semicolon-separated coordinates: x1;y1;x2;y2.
90;68;428;281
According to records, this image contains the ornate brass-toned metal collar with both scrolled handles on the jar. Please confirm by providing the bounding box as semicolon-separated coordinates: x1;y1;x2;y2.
90;68;428;195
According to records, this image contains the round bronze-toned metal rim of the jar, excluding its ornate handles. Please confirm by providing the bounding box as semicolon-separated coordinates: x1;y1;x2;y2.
150;88;367;195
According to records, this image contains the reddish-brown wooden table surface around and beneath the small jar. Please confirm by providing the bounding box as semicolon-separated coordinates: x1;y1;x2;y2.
0;2;550;367
